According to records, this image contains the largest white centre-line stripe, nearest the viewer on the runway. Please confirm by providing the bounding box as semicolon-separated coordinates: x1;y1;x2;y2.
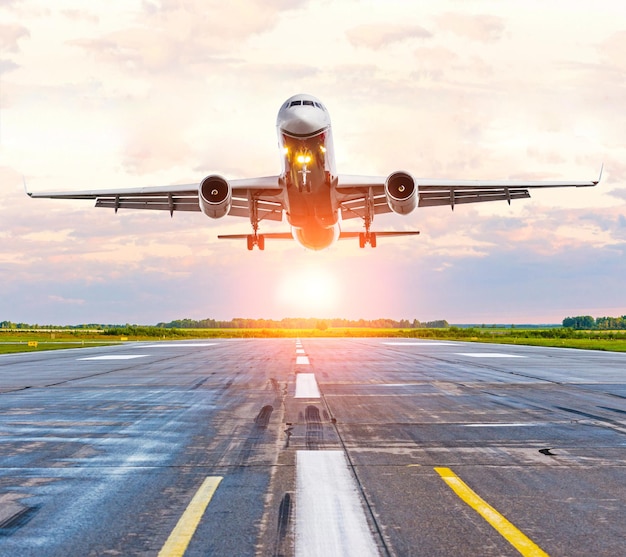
296;451;378;557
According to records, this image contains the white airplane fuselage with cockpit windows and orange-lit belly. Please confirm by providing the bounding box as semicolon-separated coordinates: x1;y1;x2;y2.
276;95;340;250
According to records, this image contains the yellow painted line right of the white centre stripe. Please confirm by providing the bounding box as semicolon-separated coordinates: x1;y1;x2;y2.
435;468;548;557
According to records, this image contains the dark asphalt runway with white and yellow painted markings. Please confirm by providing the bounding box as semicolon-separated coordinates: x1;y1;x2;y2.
0;338;626;557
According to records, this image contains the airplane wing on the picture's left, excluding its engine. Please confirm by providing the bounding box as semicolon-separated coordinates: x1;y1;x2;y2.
27;176;283;221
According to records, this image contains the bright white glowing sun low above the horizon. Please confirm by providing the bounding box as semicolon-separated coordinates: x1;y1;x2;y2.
276;267;338;317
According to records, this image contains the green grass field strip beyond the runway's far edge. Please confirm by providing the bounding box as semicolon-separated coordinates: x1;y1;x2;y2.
0;326;626;354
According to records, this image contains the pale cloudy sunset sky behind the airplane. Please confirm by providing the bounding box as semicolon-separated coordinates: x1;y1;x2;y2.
0;0;626;324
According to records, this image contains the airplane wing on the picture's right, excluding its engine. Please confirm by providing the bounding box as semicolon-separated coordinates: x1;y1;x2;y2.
337;171;602;219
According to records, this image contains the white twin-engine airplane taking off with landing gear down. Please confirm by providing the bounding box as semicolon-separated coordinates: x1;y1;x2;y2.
27;94;602;250
